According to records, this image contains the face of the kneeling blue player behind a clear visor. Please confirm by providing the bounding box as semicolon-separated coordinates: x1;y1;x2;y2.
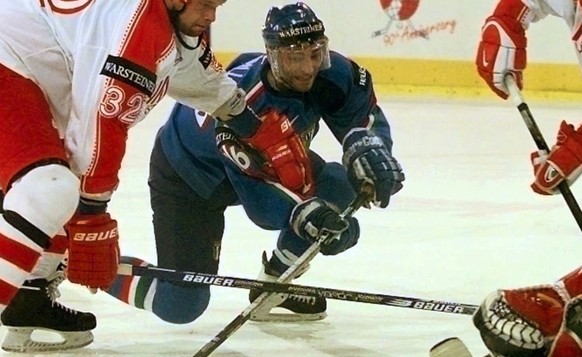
279;45;323;92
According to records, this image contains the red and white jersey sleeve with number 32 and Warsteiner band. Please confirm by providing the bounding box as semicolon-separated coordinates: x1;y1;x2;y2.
65;1;175;197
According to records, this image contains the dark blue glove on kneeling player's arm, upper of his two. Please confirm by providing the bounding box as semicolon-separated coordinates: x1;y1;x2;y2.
342;129;404;208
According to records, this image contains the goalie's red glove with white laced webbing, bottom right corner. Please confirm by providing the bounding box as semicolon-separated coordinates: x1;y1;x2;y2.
473;285;566;357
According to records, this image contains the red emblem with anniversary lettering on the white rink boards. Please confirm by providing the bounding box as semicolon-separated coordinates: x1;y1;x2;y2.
372;0;457;46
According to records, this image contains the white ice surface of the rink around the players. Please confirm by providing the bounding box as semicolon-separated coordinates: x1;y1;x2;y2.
2;93;582;357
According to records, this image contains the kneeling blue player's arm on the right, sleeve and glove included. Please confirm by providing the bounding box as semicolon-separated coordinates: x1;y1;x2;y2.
318;52;404;207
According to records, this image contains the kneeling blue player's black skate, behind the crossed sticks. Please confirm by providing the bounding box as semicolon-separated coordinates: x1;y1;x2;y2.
249;253;327;322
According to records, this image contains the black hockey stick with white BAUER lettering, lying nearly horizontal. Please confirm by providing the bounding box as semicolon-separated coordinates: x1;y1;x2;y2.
118;264;478;315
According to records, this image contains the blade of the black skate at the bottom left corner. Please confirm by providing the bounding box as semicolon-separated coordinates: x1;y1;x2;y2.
1;326;93;353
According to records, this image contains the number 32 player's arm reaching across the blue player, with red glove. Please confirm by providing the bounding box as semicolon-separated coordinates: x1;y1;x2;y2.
168;43;313;196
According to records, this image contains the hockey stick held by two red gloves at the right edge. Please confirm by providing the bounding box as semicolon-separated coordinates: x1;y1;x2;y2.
505;75;582;230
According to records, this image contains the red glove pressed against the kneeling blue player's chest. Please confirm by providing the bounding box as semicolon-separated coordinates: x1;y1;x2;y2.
245;111;314;196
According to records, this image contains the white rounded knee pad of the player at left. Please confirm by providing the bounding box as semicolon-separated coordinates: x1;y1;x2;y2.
4;164;79;237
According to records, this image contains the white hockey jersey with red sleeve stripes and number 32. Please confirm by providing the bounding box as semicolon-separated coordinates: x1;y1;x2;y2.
0;0;236;194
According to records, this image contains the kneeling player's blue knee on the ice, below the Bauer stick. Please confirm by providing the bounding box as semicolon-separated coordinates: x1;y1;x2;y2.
152;280;210;324
